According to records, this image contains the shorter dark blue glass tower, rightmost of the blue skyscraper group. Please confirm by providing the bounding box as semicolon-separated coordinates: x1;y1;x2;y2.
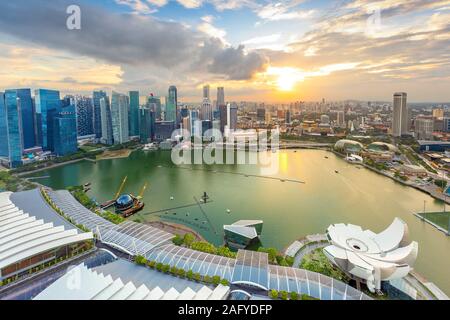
53;104;78;156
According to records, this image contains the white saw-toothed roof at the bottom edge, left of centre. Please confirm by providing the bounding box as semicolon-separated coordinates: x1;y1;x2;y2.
34;264;230;300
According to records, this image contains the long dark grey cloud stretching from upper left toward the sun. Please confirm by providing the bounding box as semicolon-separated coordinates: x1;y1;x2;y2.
0;0;265;79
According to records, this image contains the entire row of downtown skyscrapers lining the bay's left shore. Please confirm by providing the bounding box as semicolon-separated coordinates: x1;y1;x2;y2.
0;86;237;168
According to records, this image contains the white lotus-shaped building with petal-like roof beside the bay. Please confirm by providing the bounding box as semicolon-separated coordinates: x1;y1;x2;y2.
324;218;418;292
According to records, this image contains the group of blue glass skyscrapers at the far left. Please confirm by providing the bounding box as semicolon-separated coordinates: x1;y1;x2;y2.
0;89;77;167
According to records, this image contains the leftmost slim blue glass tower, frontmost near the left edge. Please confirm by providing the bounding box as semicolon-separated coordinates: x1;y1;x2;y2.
2;90;23;168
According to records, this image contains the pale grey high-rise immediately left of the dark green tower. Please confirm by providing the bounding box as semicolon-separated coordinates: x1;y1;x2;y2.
111;92;130;144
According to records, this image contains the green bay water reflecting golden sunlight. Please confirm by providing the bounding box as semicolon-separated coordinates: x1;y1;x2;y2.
27;150;450;294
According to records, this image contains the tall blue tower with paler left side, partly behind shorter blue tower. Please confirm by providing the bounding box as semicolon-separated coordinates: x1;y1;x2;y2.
35;89;61;151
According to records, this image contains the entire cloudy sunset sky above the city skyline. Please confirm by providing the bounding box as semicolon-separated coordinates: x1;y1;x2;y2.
0;0;450;103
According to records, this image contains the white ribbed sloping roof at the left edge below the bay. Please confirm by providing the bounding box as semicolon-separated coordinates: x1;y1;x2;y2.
0;192;93;277
